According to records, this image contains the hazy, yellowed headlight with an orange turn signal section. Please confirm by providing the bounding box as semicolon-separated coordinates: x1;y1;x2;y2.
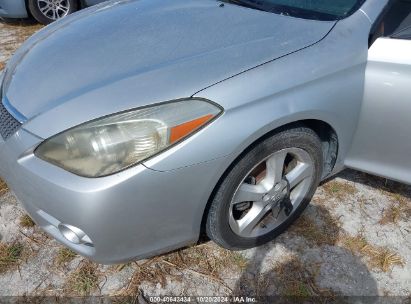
34;99;222;177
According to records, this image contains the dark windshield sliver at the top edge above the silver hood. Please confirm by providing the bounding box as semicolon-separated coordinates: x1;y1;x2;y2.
222;0;365;20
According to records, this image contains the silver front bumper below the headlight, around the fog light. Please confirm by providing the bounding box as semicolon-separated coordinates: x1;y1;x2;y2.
0;129;226;264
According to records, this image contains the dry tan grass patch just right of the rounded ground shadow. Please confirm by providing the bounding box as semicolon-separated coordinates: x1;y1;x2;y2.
341;235;404;272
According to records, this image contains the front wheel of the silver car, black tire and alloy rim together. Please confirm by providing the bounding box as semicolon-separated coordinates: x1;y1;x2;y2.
206;127;323;250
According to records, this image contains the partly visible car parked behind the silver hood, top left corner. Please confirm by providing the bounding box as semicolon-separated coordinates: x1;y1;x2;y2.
0;0;105;24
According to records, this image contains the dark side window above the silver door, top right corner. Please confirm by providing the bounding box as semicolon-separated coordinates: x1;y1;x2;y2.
370;0;411;45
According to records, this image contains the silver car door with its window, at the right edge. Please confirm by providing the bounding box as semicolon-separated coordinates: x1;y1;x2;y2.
346;0;411;184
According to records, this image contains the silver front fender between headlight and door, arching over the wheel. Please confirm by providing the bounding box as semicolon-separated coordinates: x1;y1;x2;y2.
145;11;371;171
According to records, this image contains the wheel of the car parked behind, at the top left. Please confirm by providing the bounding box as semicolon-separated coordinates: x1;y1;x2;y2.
28;0;78;24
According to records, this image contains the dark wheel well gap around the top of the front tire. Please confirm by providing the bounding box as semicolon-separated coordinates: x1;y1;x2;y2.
200;119;338;238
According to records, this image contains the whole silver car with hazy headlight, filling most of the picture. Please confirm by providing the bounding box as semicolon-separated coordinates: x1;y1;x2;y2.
0;0;411;263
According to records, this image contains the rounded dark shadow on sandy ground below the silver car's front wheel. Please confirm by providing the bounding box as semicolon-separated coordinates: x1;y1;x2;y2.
233;205;378;303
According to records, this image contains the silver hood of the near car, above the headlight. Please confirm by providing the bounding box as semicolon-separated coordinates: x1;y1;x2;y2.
3;0;334;136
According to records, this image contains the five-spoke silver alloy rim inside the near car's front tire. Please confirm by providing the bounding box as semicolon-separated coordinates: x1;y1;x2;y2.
229;148;314;238
